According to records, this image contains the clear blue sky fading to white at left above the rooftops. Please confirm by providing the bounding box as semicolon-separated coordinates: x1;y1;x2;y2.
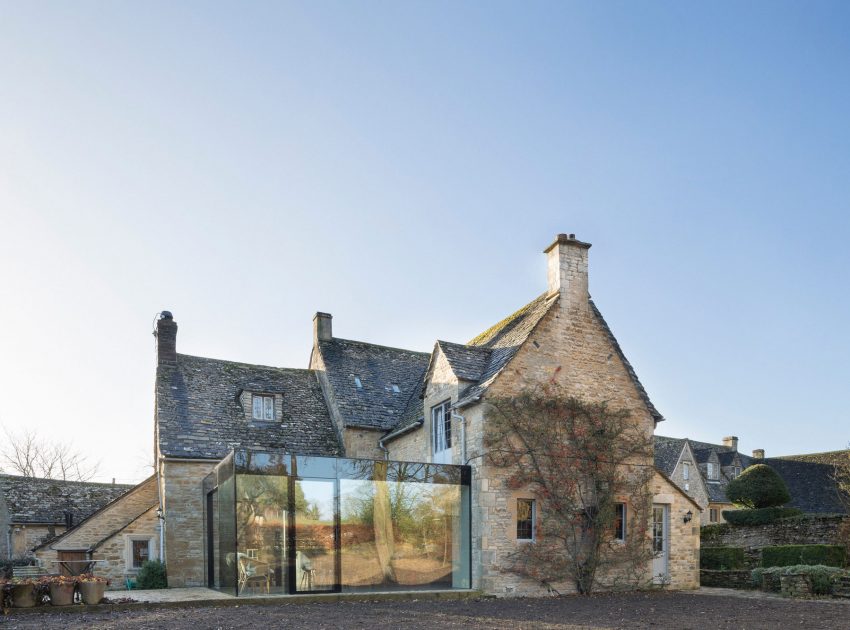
0;1;850;481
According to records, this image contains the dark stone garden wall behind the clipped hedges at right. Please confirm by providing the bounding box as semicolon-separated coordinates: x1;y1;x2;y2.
702;516;850;550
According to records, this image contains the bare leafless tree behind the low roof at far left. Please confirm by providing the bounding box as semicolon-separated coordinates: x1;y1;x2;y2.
0;429;98;481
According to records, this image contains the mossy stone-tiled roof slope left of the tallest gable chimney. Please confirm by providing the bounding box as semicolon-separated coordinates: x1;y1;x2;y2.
457;293;558;406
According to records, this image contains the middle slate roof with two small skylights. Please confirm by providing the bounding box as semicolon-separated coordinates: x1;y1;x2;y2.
319;337;430;431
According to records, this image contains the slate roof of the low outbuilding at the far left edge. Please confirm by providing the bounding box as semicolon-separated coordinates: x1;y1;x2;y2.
0;475;134;525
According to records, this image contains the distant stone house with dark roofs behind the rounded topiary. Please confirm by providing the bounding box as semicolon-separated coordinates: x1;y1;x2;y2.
655;435;850;525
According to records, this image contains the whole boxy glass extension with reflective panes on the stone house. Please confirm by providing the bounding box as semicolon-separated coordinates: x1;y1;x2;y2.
204;450;471;595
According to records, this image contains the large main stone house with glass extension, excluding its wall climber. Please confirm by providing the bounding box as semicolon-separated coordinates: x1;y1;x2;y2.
39;234;700;595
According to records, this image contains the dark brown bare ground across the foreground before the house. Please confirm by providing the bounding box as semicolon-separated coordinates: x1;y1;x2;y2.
0;593;850;630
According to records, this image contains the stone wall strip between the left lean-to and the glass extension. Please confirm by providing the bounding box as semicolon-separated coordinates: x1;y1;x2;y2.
160;459;217;586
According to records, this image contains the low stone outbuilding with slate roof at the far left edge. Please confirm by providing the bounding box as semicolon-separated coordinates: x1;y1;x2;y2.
0;475;133;559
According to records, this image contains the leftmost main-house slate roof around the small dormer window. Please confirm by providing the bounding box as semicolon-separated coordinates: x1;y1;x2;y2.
156;354;340;459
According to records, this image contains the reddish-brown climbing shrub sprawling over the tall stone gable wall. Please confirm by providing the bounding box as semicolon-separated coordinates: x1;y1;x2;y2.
485;384;653;594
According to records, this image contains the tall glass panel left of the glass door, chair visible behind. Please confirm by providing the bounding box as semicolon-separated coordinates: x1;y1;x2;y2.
236;474;289;595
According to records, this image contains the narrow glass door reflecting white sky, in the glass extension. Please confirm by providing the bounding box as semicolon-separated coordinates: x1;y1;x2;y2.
295;479;337;592
